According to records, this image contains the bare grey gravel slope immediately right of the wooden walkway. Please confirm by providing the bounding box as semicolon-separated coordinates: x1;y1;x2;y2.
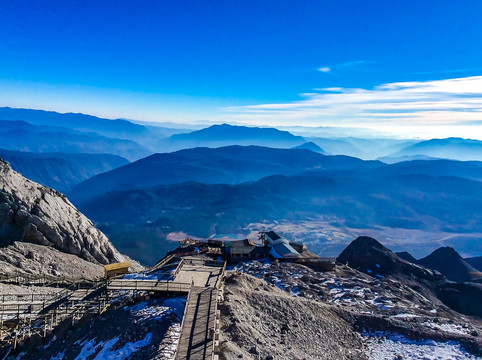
221;274;367;360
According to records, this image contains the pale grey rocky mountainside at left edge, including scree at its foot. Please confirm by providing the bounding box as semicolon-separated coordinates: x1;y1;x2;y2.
0;160;133;276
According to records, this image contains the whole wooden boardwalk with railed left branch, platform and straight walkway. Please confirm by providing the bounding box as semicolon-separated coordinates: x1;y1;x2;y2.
0;257;226;360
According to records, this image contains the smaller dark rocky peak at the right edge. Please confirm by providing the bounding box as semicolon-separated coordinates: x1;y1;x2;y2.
418;246;482;282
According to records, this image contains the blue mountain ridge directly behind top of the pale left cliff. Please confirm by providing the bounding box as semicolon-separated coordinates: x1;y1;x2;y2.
0;149;129;193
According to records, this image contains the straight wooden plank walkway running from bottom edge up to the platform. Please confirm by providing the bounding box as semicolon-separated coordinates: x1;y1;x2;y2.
176;287;217;360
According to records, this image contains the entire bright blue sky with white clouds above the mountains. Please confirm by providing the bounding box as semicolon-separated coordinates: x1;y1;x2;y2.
0;0;482;136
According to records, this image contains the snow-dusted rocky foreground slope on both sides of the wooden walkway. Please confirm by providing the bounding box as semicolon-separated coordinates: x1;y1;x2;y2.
2;237;482;360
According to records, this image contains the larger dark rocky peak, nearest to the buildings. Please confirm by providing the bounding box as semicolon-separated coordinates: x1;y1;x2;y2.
337;236;443;281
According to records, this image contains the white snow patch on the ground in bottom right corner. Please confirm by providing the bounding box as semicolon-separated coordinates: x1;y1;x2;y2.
363;332;478;360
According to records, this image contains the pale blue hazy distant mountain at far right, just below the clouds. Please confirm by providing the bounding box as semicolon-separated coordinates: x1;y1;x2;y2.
392;138;482;161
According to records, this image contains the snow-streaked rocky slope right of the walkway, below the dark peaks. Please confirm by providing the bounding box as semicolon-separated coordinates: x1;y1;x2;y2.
233;261;482;360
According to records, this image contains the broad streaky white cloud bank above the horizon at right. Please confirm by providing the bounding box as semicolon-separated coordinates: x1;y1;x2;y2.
227;76;482;136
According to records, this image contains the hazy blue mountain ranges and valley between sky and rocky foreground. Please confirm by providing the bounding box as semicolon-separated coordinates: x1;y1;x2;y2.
0;108;482;264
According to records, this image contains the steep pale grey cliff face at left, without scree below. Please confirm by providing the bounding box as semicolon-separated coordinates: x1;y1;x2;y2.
0;159;125;264
